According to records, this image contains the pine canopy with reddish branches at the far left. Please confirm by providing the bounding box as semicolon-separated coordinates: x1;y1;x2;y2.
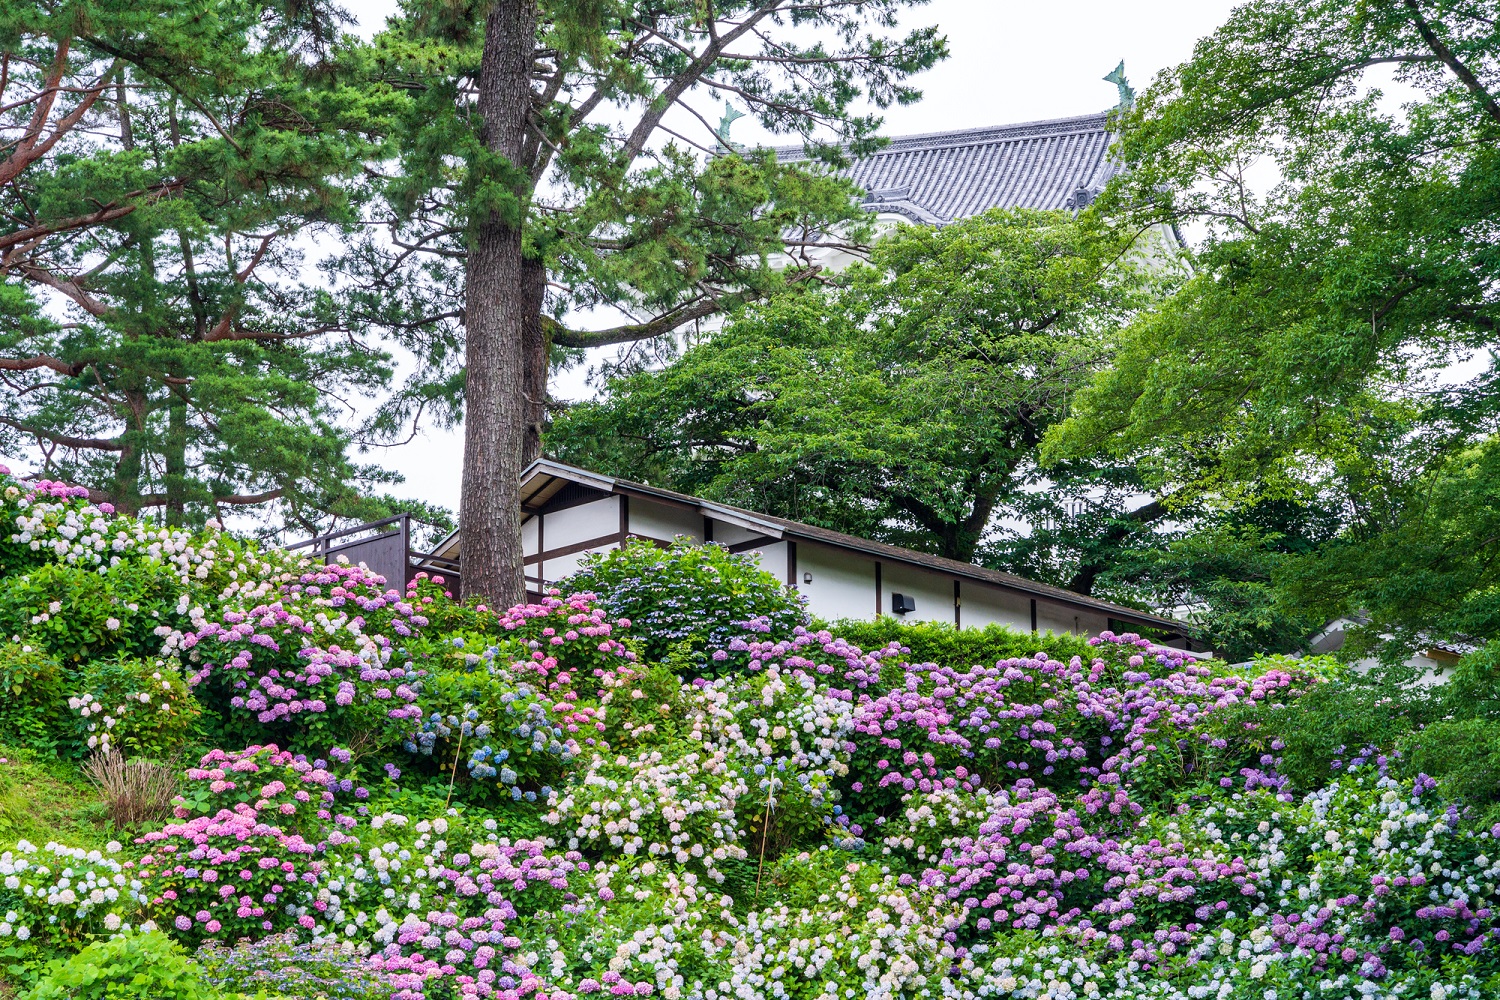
0;0;411;525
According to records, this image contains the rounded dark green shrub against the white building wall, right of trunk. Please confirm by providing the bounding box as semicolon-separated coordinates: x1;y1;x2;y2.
558;538;807;673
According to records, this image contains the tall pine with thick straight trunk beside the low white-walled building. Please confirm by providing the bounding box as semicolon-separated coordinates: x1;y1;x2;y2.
345;0;945;601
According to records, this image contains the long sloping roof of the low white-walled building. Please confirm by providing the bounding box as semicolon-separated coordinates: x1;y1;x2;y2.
432;459;1190;633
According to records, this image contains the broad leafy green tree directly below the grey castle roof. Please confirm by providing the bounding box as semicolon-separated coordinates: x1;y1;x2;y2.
549;210;1158;561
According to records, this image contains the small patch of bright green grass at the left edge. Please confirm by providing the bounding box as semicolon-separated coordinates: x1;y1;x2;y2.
0;744;117;851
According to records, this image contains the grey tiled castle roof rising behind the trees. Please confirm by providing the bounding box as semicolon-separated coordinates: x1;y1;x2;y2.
777;112;1116;223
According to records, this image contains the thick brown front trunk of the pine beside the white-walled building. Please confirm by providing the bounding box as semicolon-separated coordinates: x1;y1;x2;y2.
459;0;537;606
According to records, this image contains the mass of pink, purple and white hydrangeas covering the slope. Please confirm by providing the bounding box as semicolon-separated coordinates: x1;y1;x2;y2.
0;467;1500;1000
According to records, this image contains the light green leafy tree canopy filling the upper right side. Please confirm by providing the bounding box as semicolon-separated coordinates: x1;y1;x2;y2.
1047;0;1500;651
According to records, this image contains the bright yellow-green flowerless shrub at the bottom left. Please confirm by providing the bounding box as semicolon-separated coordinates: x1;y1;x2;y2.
24;933;221;1000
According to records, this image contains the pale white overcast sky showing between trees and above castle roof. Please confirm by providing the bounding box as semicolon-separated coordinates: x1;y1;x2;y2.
347;0;1235;511
